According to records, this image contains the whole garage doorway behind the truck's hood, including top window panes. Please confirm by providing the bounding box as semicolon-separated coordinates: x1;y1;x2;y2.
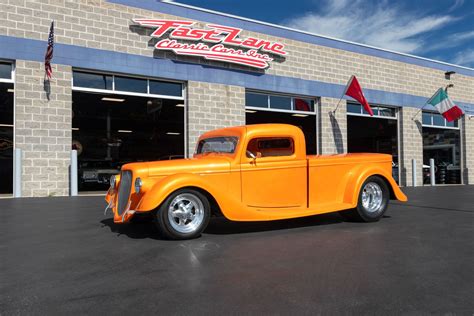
72;71;185;191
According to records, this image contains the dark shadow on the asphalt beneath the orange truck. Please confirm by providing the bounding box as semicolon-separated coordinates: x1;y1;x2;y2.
100;213;356;240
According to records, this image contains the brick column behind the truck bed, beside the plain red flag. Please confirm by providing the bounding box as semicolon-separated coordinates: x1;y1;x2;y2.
318;98;347;154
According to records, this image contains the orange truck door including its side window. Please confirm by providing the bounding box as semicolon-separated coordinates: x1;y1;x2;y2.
241;137;307;208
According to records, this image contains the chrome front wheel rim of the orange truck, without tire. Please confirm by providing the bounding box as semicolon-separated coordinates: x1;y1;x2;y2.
168;193;204;234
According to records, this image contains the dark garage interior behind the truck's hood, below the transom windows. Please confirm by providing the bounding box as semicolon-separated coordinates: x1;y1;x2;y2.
72;91;184;191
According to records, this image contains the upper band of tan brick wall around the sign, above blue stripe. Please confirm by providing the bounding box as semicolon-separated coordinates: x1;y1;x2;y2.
0;0;474;103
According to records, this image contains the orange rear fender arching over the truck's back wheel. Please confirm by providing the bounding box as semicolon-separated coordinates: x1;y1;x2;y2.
344;166;408;207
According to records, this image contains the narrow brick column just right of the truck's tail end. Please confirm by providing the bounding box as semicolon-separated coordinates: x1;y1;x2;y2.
398;107;423;186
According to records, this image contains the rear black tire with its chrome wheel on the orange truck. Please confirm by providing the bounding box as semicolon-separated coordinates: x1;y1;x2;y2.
339;176;390;222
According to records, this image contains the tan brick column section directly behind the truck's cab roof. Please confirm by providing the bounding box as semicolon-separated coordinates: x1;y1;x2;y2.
187;81;245;156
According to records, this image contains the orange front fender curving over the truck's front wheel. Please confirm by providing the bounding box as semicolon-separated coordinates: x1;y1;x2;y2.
135;173;219;212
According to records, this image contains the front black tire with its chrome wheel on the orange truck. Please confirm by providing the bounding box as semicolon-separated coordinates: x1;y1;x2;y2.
154;189;211;240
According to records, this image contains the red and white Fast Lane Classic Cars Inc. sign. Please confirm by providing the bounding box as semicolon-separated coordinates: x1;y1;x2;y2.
133;19;288;69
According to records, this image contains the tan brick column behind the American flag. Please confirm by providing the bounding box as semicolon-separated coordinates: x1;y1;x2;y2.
15;60;72;197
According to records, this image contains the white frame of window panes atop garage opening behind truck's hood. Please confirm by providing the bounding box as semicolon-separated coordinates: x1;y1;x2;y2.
71;69;186;100
